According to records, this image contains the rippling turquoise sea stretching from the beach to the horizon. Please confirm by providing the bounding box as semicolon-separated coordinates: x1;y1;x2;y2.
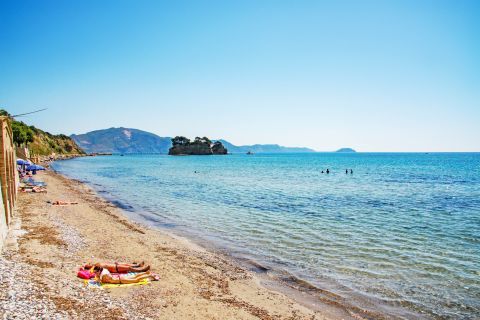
53;153;480;319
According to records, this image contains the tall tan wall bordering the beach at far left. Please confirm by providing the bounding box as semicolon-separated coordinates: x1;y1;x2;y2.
0;117;18;250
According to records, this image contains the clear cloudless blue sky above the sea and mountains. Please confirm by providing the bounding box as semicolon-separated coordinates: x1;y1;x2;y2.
0;0;480;151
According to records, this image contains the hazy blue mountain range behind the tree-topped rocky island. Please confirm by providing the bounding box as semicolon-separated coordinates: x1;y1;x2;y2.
70;127;315;154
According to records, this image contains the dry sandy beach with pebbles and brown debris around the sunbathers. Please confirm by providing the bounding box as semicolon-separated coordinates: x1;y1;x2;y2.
0;171;343;320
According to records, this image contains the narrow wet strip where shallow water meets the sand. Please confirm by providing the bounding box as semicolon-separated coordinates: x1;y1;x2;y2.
46;161;422;319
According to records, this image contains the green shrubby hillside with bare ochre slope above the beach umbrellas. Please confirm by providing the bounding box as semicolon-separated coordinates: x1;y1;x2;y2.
0;110;85;156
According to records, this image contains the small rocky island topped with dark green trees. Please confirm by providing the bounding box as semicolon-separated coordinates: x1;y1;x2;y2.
168;136;227;156
